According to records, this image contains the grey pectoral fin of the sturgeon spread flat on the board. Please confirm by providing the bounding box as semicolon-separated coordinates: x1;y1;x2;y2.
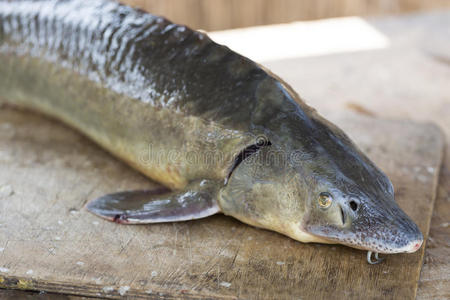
86;180;220;224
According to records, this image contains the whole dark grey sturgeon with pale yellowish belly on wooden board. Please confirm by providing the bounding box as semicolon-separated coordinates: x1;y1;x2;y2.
0;0;423;263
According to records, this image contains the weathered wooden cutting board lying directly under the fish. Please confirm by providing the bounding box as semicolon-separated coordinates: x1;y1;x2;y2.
0;108;443;299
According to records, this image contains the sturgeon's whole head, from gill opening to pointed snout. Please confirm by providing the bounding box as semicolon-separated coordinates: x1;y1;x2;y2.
219;113;423;253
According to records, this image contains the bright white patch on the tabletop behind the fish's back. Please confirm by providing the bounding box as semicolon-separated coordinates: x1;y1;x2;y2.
208;17;389;62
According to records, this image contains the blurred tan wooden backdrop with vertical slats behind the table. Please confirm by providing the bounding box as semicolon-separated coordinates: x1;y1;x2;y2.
122;0;450;30
